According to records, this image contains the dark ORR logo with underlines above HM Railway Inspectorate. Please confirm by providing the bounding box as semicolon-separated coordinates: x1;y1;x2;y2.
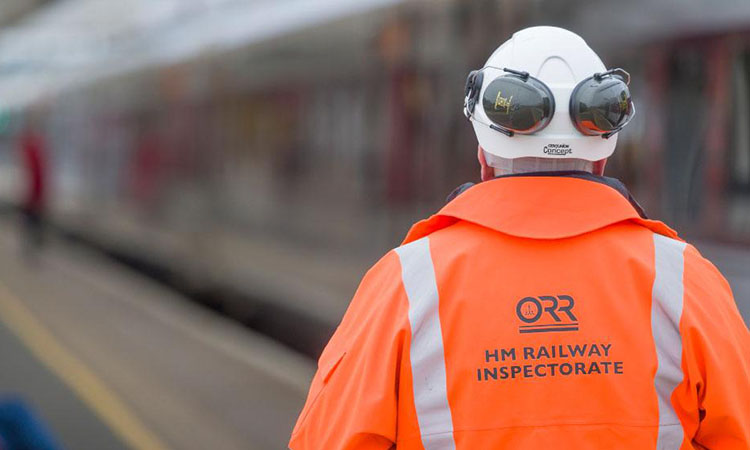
516;295;578;333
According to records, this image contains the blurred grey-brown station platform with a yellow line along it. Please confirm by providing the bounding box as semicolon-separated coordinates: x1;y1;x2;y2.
0;220;314;449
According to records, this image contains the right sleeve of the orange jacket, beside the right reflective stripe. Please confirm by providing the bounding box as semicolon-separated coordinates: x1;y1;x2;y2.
675;246;750;450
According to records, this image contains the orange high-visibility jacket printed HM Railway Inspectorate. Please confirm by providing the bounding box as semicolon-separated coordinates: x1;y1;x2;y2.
289;176;750;450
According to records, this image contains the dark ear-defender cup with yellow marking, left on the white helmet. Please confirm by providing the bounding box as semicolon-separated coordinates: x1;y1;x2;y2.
482;75;554;134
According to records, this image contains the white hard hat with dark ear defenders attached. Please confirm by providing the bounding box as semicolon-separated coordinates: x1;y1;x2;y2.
464;27;635;161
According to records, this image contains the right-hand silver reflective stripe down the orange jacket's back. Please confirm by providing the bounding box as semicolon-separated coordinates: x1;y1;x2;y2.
651;234;685;450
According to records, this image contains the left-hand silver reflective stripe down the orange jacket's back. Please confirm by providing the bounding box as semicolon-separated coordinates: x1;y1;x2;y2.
396;237;456;450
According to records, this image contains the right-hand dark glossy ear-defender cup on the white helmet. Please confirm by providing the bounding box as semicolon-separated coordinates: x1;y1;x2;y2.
570;76;633;135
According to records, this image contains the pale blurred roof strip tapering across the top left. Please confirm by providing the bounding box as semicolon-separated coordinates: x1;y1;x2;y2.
0;0;402;109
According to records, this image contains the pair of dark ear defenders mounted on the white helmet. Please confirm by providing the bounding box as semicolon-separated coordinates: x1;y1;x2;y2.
464;66;635;139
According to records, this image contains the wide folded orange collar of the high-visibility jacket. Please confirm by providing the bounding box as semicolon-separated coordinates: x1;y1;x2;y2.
404;174;678;243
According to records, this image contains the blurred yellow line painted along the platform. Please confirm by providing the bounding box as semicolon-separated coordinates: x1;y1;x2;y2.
0;282;167;450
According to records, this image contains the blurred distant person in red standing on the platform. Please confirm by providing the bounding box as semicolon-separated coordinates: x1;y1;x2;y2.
20;120;47;259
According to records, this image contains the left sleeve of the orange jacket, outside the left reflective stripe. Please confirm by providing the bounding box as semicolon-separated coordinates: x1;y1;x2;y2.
289;252;408;450
